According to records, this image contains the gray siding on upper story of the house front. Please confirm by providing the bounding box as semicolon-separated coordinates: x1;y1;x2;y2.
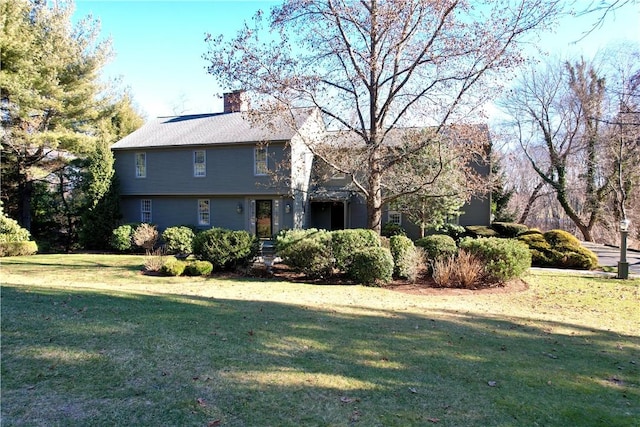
114;144;287;196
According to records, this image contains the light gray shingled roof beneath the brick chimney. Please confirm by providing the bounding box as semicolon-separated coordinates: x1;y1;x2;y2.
111;109;312;150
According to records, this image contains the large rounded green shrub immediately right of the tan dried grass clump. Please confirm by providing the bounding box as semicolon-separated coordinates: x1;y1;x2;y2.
460;237;531;282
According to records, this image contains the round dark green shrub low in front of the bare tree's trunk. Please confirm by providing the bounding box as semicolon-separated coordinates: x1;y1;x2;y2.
347;246;393;286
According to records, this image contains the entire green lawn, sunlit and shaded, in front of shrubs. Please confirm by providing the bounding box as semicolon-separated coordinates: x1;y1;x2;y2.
0;255;640;426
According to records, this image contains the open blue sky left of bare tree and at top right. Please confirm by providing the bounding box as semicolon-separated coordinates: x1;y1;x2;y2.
75;0;640;118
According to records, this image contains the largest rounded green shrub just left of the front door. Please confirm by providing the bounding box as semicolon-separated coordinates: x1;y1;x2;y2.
193;227;258;271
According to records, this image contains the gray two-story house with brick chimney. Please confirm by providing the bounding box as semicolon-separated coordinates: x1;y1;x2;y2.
111;92;490;239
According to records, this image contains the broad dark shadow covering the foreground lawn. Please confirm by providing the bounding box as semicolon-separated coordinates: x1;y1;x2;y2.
2;285;640;426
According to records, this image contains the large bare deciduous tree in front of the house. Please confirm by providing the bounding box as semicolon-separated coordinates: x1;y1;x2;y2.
205;0;561;231
